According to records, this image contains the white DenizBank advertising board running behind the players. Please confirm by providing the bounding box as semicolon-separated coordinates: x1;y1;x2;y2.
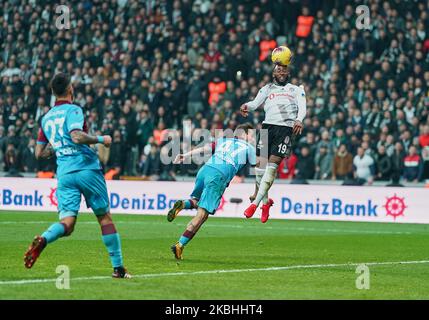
0;178;429;224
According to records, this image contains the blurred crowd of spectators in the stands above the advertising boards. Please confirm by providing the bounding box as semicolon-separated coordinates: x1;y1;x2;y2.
0;0;429;184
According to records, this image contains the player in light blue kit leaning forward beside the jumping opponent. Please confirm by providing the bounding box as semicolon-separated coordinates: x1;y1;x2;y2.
167;123;256;259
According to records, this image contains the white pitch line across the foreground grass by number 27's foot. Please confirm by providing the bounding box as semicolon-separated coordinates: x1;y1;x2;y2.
0;260;429;285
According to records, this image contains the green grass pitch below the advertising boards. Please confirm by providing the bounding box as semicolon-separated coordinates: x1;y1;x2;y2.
0;211;429;299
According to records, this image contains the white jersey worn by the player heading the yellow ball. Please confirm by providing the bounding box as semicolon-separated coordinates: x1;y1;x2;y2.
246;83;307;127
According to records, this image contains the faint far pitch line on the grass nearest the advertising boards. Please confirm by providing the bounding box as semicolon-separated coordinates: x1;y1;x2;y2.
0;221;412;234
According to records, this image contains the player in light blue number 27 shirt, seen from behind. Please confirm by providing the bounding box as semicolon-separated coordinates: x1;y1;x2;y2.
24;73;130;278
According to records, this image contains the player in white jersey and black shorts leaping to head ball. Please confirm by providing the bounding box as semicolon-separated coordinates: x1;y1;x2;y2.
240;64;307;223
